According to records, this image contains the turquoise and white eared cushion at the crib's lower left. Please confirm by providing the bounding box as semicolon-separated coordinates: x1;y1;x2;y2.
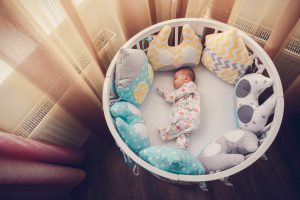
110;101;150;154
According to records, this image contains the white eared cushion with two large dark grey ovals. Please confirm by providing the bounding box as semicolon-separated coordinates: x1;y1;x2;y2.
235;73;276;134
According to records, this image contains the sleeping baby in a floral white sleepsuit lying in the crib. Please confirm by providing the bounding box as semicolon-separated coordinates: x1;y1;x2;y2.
157;67;200;149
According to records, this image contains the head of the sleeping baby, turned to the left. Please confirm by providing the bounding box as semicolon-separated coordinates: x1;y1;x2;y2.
173;67;195;89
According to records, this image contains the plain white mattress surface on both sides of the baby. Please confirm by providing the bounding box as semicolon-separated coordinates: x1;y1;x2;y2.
141;65;237;156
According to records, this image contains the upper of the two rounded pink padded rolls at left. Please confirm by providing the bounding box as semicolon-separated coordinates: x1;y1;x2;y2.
0;132;83;165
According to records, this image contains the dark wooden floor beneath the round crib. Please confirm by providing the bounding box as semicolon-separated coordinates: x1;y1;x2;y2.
71;54;300;200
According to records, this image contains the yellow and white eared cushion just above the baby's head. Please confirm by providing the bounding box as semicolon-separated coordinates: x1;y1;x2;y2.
147;24;202;71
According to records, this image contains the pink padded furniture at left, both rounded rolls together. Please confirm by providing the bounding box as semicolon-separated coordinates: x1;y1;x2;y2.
0;132;86;191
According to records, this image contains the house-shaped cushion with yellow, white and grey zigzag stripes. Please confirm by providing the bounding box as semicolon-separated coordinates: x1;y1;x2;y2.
201;29;252;84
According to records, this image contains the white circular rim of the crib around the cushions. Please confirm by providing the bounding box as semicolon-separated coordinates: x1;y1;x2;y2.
103;18;284;183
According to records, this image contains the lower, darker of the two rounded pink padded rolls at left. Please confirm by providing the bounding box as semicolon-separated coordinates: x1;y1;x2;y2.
0;157;85;188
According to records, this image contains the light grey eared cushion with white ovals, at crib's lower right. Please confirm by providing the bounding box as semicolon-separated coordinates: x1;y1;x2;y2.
198;130;258;172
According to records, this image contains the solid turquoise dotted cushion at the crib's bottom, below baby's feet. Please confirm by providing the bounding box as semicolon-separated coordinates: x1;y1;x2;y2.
139;146;205;175
